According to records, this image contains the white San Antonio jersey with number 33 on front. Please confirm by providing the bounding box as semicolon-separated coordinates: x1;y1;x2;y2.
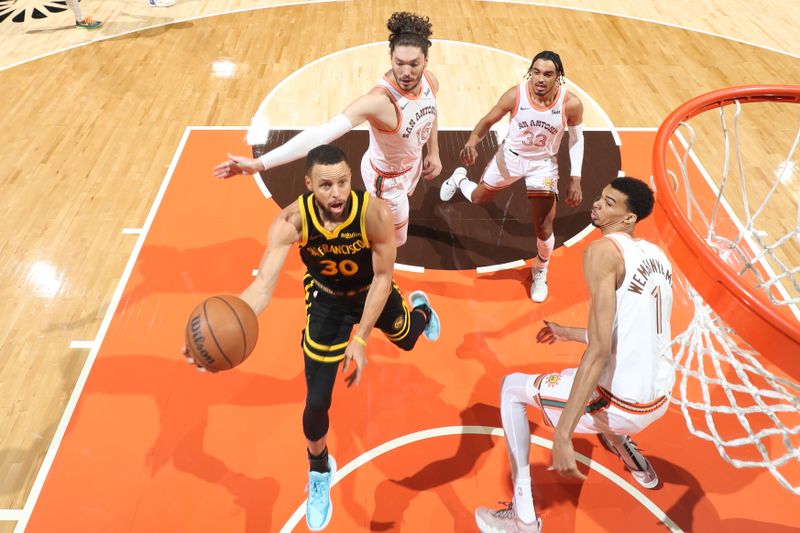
505;81;569;162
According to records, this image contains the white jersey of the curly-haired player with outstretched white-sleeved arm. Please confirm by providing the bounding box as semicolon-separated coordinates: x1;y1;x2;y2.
367;71;436;177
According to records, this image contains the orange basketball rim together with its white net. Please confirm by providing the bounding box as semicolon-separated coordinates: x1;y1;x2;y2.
653;85;800;495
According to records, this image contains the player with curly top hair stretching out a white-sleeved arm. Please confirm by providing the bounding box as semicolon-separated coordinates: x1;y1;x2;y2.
214;12;442;246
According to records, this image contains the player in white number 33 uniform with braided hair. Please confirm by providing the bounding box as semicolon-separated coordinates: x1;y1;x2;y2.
439;50;583;302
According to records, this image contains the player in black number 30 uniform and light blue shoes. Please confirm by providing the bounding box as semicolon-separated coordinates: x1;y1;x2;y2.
193;145;439;531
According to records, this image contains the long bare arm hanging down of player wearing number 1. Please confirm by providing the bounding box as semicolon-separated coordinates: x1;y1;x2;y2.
551;239;622;479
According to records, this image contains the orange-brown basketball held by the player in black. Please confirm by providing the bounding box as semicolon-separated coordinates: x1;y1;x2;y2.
186;295;258;370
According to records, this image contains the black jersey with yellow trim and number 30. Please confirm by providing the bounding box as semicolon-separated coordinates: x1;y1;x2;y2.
297;191;373;296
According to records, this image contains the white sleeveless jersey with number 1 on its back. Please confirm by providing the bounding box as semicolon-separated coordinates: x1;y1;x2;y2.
598;233;674;408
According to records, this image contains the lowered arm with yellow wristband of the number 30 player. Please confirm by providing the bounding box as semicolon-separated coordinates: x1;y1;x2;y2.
342;198;397;386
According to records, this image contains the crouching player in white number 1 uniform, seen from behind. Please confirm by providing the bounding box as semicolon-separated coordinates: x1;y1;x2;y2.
475;178;674;532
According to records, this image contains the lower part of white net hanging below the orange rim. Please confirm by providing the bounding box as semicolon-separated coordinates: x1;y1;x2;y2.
672;288;800;495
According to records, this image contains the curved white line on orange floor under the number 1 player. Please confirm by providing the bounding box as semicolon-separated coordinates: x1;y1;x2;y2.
280;426;683;533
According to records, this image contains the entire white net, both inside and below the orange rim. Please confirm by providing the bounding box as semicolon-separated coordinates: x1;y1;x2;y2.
666;90;800;495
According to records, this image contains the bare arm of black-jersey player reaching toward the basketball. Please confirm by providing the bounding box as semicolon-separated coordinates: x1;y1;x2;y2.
240;202;302;314
